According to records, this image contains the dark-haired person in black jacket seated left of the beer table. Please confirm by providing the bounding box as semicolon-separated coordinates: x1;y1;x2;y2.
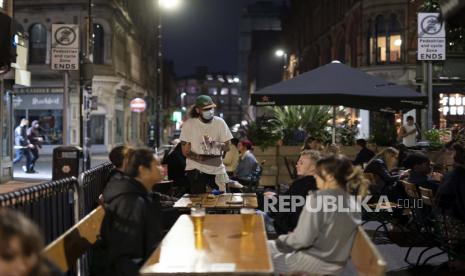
101;149;163;276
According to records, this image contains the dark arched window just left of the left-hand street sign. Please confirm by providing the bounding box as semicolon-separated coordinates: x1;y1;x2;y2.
29;24;47;64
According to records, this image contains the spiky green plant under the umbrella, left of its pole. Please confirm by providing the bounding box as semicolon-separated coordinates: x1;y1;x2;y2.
267;106;332;145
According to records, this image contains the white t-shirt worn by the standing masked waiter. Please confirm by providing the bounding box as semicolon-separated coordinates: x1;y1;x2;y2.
179;116;233;175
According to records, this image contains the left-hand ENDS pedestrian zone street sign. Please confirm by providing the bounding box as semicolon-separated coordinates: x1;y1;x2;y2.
51;24;79;71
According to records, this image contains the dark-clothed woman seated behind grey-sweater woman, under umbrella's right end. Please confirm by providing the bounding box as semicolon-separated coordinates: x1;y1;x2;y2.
365;148;404;201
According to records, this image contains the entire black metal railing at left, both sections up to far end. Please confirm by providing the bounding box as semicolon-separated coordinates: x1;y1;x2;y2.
0;162;113;244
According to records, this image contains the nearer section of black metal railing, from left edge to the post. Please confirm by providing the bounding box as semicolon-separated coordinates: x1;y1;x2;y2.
0;177;79;244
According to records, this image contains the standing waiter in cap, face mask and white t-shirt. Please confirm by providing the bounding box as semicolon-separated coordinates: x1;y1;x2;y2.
179;95;233;194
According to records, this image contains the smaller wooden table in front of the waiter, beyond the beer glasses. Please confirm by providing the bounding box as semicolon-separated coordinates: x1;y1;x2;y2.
173;193;258;211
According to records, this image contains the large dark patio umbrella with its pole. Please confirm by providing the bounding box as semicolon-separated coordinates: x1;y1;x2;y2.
252;61;427;143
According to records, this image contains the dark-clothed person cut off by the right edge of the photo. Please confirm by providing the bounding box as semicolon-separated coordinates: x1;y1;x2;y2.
436;143;465;223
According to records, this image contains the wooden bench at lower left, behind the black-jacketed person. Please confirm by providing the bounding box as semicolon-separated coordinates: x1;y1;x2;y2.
44;206;105;271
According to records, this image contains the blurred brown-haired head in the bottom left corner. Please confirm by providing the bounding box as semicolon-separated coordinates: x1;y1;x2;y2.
0;208;63;276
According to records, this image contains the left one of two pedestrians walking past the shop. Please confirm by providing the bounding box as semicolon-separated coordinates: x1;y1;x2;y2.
13;118;34;173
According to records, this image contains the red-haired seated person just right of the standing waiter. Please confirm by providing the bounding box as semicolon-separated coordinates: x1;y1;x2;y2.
234;140;258;184
